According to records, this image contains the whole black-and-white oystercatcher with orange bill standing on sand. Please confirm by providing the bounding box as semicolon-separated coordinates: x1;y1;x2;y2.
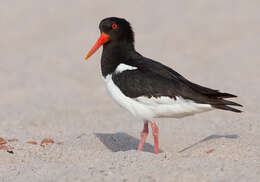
85;17;242;154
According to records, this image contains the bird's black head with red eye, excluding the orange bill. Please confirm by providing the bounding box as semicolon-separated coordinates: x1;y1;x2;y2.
99;17;134;43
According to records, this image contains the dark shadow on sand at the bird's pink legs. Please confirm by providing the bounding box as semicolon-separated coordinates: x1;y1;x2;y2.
95;132;162;153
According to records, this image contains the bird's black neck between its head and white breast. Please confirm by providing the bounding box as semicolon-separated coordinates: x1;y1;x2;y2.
101;41;138;77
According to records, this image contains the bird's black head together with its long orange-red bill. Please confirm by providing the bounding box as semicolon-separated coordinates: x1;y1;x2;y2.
85;17;134;60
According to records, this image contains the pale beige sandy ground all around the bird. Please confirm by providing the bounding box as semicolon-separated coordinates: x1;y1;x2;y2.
0;0;260;182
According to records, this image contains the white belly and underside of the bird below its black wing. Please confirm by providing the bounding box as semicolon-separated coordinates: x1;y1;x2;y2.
104;70;213;120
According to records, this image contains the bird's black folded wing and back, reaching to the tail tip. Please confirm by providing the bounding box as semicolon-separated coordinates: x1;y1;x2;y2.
112;57;241;112
